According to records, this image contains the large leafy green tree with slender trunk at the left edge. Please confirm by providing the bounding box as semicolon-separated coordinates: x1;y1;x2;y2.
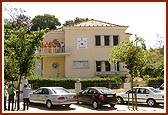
4;5;47;110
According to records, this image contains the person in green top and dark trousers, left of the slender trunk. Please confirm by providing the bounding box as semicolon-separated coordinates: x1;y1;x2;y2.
7;84;16;111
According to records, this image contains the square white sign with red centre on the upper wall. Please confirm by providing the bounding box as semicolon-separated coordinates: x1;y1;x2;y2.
77;37;87;48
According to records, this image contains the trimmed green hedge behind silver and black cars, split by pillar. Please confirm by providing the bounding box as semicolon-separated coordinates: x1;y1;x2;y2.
28;77;122;89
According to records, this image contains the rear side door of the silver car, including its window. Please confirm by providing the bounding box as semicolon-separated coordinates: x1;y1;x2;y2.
39;88;49;104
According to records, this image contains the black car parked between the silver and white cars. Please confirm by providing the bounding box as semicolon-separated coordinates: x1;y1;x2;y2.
77;87;117;109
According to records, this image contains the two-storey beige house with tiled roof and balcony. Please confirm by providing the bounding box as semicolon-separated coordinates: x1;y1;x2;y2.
35;19;131;78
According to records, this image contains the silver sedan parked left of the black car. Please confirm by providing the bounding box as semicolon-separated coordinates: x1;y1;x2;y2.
30;87;77;108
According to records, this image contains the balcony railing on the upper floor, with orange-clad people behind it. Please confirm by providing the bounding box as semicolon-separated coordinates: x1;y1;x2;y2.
36;47;65;53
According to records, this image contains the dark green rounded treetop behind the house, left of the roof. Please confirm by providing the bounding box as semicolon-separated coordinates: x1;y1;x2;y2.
31;14;61;31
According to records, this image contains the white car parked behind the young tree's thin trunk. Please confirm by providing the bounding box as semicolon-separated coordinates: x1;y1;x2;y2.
116;87;164;106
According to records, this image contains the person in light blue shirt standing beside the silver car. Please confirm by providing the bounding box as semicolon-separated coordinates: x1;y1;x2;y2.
22;84;30;110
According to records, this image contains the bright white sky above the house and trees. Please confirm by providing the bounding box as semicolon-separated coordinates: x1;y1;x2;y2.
2;2;166;48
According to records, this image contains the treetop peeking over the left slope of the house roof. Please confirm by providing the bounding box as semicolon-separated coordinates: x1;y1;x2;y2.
63;17;88;26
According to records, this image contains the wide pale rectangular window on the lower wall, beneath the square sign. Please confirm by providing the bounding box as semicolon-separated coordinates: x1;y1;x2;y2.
72;61;89;69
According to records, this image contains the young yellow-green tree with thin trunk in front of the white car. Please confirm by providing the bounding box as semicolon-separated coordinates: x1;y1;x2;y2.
109;37;148;109
